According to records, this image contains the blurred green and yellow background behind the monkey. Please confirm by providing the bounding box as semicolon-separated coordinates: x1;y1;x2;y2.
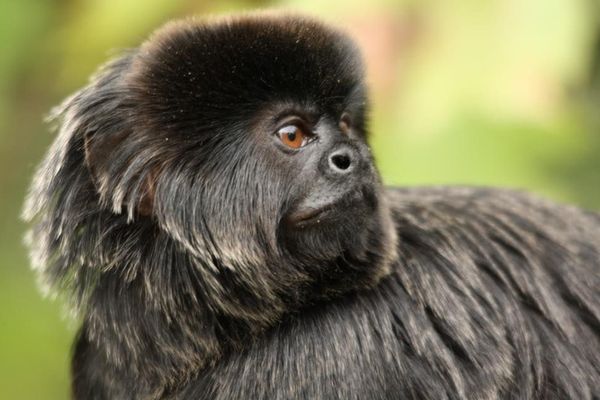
0;0;600;399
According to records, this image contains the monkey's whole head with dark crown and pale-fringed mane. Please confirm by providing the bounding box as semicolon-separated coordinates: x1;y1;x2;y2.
26;15;395;382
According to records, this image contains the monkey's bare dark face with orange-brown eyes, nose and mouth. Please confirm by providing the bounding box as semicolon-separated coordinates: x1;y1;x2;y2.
259;101;380;262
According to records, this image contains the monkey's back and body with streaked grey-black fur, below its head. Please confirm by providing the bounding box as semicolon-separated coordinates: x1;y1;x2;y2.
74;187;600;400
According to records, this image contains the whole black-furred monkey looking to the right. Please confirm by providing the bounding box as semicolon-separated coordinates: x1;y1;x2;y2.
24;13;600;400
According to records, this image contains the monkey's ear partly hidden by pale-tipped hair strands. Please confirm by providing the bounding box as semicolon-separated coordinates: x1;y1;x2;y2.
84;130;158;217
